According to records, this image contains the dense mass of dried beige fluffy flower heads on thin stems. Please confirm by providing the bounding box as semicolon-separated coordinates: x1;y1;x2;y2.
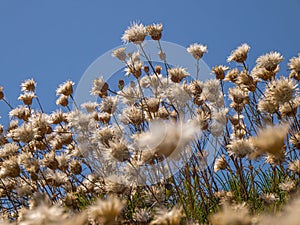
0;23;300;225
